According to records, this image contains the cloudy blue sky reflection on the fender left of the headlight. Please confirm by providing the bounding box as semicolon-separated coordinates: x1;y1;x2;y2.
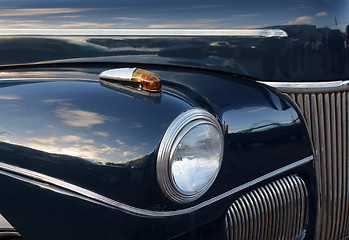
0;79;185;164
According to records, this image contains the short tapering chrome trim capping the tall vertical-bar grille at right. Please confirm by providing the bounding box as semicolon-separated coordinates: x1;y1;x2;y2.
257;80;349;93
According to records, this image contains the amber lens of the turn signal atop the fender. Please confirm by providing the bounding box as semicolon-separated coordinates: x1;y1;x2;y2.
131;68;161;92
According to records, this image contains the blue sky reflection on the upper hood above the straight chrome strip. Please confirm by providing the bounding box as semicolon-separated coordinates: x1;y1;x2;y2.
0;0;349;29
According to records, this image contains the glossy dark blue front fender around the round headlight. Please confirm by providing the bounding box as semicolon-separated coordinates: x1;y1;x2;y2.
0;64;316;239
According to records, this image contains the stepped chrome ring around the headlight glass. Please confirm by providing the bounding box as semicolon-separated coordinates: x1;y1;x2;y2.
156;108;224;203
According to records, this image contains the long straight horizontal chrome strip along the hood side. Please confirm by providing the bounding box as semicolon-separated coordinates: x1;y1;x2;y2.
0;29;288;37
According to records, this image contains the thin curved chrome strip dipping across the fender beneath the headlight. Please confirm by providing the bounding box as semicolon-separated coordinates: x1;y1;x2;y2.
0;155;314;217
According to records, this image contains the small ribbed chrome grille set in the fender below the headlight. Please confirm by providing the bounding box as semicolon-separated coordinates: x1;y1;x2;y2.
226;176;308;240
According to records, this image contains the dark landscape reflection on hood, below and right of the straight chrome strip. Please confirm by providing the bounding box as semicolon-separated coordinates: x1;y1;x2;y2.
0;31;349;82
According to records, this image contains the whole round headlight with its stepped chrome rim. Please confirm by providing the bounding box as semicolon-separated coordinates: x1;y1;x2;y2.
157;109;223;203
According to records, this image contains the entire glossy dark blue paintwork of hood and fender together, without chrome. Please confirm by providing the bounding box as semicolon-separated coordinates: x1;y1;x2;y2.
0;0;334;239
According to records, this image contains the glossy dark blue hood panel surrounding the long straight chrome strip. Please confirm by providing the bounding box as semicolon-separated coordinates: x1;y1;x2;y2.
0;0;349;81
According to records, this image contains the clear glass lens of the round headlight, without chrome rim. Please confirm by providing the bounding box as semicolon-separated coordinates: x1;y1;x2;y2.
171;124;222;193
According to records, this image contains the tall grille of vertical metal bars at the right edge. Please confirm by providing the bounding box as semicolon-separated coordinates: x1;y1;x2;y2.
288;91;349;240
